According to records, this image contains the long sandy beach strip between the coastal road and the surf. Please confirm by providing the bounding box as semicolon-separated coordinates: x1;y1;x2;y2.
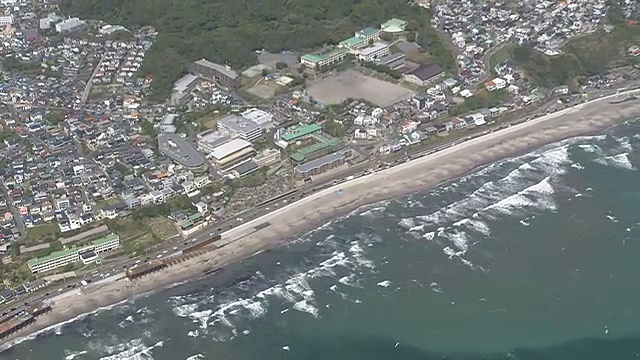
0;90;640;352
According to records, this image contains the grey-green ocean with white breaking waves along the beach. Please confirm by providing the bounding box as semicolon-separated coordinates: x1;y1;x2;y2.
0;121;640;360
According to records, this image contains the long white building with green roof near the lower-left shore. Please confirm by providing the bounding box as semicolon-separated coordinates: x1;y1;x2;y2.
27;234;120;274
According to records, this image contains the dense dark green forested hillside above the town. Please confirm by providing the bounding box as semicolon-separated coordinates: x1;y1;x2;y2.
61;0;453;97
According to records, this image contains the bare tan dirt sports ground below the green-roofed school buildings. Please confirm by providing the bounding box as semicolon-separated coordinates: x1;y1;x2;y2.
307;70;415;107
